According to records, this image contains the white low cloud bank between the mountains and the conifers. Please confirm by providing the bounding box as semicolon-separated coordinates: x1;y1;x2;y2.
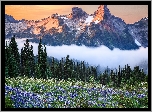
5;39;148;73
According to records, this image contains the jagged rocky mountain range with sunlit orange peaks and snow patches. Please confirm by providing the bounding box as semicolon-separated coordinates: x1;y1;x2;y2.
5;5;148;50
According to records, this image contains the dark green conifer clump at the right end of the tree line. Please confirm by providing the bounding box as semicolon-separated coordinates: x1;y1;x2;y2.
98;64;148;87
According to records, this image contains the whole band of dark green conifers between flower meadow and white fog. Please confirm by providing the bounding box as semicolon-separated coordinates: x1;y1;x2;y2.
5;36;148;86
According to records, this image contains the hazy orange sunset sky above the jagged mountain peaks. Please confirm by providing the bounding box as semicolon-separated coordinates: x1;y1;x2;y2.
5;5;148;23
